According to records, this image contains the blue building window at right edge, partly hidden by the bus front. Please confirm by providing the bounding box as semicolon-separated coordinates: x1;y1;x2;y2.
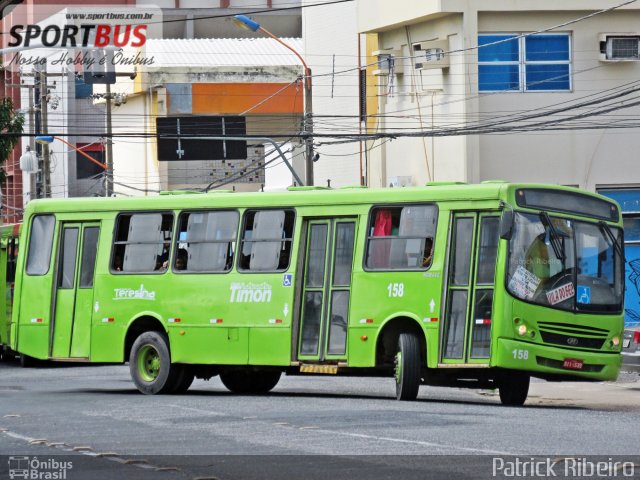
598;188;640;326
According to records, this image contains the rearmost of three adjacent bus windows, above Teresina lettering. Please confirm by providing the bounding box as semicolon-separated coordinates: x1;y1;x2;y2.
111;213;173;273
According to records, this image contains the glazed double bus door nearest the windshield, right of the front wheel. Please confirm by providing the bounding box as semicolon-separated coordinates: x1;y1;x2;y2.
441;212;500;364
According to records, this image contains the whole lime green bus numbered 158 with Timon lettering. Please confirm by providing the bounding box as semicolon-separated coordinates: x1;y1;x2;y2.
11;182;624;405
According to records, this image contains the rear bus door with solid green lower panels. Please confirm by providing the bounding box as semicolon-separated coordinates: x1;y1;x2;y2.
49;222;100;359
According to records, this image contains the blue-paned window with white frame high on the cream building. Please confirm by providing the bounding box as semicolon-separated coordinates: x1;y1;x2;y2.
478;33;571;92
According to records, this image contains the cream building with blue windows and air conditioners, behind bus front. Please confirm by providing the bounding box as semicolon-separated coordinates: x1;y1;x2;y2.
358;0;640;322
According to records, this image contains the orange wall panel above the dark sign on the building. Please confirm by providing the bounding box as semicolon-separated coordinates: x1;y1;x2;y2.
192;83;304;114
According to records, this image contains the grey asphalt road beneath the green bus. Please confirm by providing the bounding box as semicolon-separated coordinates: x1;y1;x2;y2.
0;364;640;480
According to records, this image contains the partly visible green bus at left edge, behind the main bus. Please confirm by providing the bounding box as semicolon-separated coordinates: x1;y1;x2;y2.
0;224;20;359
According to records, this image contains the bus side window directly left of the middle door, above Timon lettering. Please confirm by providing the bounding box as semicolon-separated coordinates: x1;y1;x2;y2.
238;210;295;272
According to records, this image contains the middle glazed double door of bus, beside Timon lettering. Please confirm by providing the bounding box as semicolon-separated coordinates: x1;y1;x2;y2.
297;218;356;362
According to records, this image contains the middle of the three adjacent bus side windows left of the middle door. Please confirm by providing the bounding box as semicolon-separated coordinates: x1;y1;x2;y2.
178;211;240;272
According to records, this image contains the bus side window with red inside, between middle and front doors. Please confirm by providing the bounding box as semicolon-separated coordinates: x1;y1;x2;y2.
366;205;438;270
